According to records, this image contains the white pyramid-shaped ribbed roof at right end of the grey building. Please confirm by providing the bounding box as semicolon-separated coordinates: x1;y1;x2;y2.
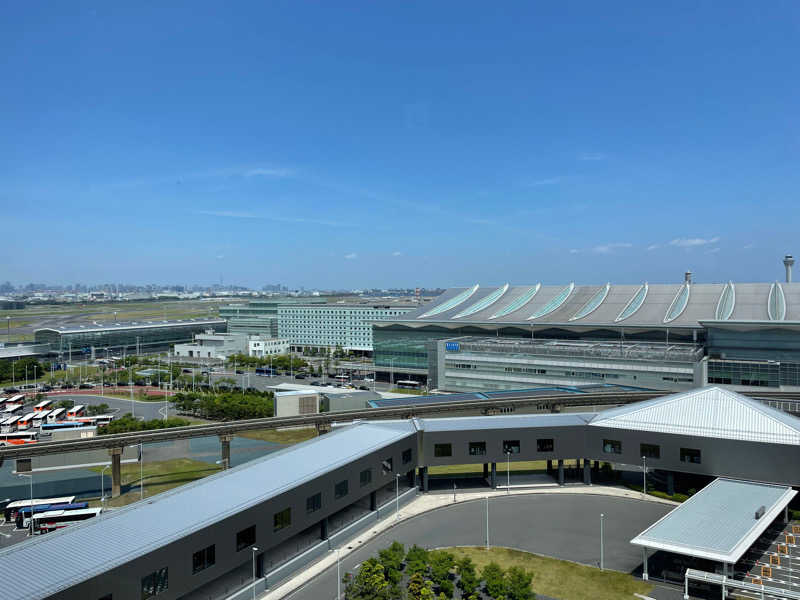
590;387;800;445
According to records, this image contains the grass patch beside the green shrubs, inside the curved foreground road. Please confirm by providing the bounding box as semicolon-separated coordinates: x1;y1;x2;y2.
445;547;653;600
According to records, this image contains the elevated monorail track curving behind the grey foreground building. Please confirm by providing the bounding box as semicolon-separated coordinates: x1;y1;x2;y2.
0;391;800;462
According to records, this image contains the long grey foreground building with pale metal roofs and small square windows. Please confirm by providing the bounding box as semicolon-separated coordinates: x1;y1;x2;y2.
0;387;800;600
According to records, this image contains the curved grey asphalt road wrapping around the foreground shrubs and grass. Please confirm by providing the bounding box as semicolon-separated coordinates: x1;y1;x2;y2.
286;494;672;600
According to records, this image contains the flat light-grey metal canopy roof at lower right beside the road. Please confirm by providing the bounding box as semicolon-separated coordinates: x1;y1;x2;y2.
631;478;797;564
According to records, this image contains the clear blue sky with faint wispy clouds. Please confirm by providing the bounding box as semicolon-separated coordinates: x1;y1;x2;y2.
0;0;800;288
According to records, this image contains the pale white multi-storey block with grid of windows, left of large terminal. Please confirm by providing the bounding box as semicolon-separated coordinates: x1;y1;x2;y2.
278;304;418;352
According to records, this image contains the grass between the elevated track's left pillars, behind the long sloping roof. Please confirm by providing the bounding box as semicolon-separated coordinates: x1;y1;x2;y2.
89;460;221;507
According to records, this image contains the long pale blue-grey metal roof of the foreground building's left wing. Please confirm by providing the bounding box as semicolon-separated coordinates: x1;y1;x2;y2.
0;421;416;600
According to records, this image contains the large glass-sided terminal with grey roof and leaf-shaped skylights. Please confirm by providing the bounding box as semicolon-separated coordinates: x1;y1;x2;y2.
373;273;800;391
